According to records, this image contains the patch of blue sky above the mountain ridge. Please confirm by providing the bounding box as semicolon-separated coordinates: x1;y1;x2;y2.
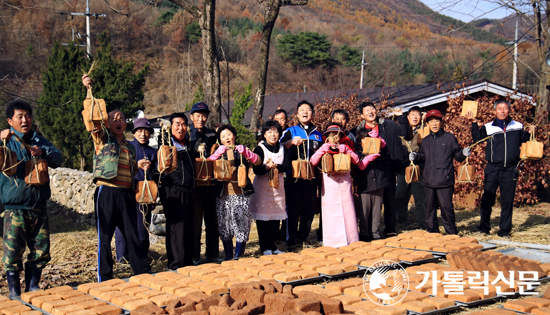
420;0;513;22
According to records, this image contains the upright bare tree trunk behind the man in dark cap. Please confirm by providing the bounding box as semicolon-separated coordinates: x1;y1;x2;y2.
170;0;222;125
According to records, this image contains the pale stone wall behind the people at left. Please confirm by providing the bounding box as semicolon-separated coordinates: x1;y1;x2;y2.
48;167;96;224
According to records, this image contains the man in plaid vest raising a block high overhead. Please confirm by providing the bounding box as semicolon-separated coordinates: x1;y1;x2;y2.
82;75;151;282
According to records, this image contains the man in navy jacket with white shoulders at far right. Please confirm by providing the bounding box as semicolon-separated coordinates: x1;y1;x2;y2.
466;99;529;237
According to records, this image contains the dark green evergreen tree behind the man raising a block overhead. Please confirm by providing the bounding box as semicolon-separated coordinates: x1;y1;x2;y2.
36;33;148;170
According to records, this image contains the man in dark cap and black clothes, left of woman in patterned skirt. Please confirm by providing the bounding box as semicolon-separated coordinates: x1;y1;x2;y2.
189;102;220;263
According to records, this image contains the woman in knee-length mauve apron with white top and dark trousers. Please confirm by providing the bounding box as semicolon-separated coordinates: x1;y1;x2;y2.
250;120;291;255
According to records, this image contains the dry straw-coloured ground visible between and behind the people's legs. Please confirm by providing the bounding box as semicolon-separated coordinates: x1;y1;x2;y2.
0;203;550;314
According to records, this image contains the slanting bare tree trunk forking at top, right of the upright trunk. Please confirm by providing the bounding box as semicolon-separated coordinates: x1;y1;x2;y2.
250;0;308;131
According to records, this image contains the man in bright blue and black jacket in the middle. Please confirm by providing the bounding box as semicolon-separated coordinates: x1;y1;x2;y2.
280;101;323;250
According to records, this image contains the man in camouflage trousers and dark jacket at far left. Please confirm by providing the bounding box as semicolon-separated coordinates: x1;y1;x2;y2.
0;101;63;298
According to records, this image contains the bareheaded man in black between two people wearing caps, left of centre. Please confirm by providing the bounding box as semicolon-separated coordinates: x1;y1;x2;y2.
158;113;195;270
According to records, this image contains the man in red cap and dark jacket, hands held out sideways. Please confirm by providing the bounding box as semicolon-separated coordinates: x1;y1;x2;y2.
409;109;470;235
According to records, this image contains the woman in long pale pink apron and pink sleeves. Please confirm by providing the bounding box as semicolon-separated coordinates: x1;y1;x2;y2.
311;123;380;247
